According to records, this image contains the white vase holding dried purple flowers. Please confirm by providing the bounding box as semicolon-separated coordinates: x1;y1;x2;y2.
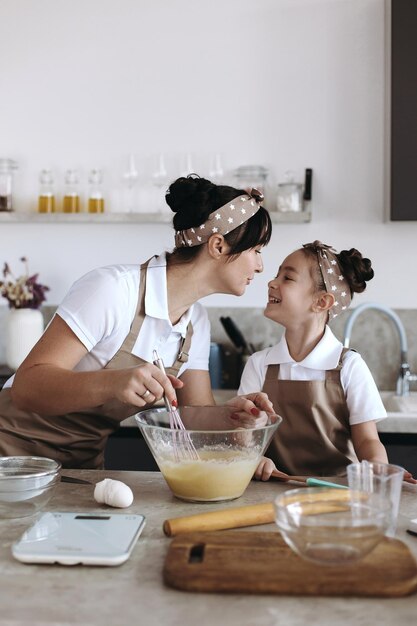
6;309;43;370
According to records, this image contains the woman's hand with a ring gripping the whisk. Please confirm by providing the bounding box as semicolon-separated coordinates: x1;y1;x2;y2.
108;363;183;407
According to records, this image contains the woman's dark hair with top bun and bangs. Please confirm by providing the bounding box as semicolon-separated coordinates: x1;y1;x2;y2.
165;174;272;261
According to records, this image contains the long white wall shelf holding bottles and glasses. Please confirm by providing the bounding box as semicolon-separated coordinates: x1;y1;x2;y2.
0;210;311;224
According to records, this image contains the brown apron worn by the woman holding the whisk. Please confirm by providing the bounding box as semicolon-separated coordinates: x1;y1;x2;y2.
0;261;193;469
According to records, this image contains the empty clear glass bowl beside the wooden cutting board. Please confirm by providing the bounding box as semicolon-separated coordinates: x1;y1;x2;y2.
274;487;390;565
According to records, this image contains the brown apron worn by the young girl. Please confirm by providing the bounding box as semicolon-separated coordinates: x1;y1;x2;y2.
262;349;358;476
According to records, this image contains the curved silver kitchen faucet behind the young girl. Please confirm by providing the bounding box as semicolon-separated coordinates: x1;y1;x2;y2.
343;302;417;396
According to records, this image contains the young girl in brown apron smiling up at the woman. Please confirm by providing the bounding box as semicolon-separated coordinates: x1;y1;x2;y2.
239;241;410;480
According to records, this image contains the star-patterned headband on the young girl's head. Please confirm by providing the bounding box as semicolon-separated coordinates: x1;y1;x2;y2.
303;241;352;320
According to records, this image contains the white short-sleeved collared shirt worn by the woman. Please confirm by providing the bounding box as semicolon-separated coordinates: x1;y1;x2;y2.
4;254;210;387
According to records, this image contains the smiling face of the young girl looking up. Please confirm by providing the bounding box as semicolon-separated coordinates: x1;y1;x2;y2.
264;250;318;326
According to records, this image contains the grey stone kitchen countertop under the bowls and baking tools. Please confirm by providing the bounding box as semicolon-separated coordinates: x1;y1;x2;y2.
0;470;417;626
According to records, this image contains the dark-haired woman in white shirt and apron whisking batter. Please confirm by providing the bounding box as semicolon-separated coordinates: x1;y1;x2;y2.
0;176;273;468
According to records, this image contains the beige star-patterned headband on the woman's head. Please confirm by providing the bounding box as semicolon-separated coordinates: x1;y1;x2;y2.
175;189;264;248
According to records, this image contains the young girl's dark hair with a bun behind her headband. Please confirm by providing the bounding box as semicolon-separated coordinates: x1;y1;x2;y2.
300;240;374;297
